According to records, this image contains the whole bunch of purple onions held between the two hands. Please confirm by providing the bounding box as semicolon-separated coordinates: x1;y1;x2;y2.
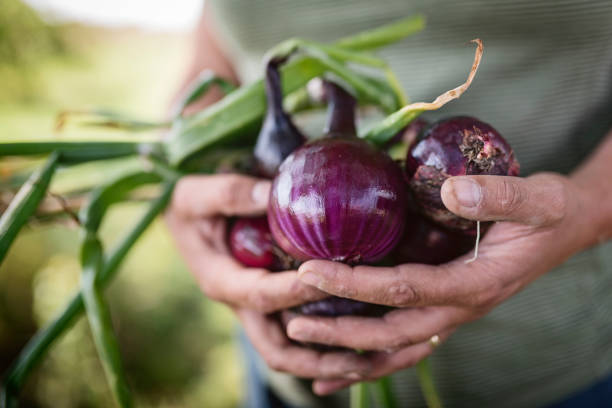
230;40;519;408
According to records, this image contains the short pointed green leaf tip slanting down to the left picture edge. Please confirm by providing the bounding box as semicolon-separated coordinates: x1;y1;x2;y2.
0;153;59;264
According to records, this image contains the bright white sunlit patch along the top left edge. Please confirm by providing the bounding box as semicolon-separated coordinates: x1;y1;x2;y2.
25;0;204;31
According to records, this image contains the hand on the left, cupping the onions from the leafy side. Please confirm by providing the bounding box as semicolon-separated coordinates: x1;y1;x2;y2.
166;174;370;380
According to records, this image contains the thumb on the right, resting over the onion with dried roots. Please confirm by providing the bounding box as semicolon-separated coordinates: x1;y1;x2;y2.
441;173;568;225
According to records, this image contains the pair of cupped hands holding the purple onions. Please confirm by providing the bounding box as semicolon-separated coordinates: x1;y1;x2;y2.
166;173;588;395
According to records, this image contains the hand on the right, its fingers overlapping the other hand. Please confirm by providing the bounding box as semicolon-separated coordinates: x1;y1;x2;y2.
287;174;590;394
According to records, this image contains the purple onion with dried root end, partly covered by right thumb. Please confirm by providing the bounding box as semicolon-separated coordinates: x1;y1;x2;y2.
405;116;519;230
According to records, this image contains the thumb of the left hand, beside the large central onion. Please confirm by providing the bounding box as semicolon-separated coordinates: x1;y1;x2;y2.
172;174;271;218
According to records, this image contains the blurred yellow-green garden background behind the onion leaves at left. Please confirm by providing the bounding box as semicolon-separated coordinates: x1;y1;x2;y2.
0;0;243;407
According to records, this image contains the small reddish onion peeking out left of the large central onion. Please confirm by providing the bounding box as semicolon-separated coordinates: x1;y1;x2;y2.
229;217;281;270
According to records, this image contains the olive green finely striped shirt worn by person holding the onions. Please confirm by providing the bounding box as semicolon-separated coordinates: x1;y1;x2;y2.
208;0;612;408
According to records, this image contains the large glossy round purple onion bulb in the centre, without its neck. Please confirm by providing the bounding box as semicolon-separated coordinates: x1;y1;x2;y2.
268;138;406;264
